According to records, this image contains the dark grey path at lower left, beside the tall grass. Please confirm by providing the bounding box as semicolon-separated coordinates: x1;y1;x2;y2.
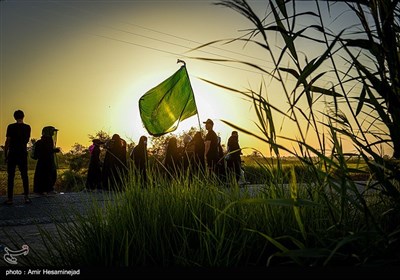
0;192;112;266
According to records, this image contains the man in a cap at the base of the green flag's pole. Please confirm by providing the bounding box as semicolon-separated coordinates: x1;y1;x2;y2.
203;119;218;175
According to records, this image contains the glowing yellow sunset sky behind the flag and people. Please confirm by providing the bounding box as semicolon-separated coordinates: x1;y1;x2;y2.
0;0;394;155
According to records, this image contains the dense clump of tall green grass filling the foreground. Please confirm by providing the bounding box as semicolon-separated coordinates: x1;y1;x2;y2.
15;164;396;267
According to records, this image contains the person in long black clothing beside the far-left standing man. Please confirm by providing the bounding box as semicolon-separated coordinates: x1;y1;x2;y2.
32;126;60;194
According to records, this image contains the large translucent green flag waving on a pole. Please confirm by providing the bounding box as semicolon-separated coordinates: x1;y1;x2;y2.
139;66;197;136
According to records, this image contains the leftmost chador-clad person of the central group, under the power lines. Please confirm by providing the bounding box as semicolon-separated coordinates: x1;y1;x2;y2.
86;139;103;191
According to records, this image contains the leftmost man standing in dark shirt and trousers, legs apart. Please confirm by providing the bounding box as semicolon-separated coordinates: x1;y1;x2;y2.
4;110;31;205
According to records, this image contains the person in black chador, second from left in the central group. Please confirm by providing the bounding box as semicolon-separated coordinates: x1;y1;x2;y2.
102;134;128;190
